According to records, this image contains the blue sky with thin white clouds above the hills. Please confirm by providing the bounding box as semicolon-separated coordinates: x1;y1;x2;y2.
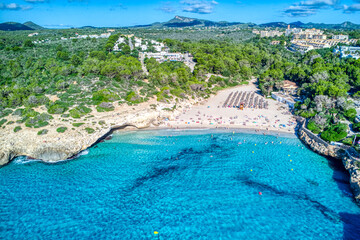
0;0;360;28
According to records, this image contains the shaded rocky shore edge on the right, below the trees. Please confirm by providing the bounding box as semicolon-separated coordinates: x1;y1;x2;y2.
298;124;360;204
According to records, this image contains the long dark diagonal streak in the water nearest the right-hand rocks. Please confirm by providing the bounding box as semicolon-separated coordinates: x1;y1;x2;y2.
239;178;340;223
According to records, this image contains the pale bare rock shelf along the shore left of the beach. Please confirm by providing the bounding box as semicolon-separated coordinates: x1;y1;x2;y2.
0;98;192;166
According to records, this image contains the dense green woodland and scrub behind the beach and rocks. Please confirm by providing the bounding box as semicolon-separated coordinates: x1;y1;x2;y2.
0;29;360;142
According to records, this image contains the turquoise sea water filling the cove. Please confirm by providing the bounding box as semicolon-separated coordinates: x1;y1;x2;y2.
0;130;360;239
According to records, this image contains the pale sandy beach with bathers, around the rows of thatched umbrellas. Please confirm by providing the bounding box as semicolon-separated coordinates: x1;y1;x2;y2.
160;80;296;133
